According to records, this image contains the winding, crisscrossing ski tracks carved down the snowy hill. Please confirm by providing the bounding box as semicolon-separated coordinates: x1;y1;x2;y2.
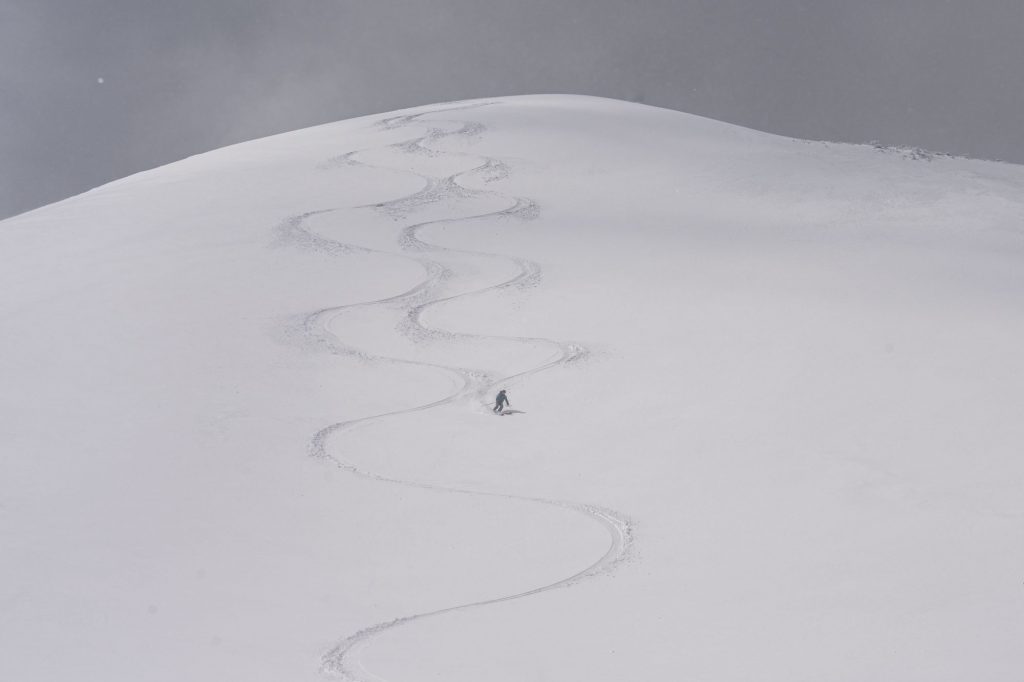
288;102;633;682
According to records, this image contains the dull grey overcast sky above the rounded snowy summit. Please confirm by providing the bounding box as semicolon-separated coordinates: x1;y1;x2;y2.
0;0;1024;217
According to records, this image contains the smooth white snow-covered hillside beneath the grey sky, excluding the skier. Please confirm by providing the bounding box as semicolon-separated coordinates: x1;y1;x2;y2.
0;96;1024;682
